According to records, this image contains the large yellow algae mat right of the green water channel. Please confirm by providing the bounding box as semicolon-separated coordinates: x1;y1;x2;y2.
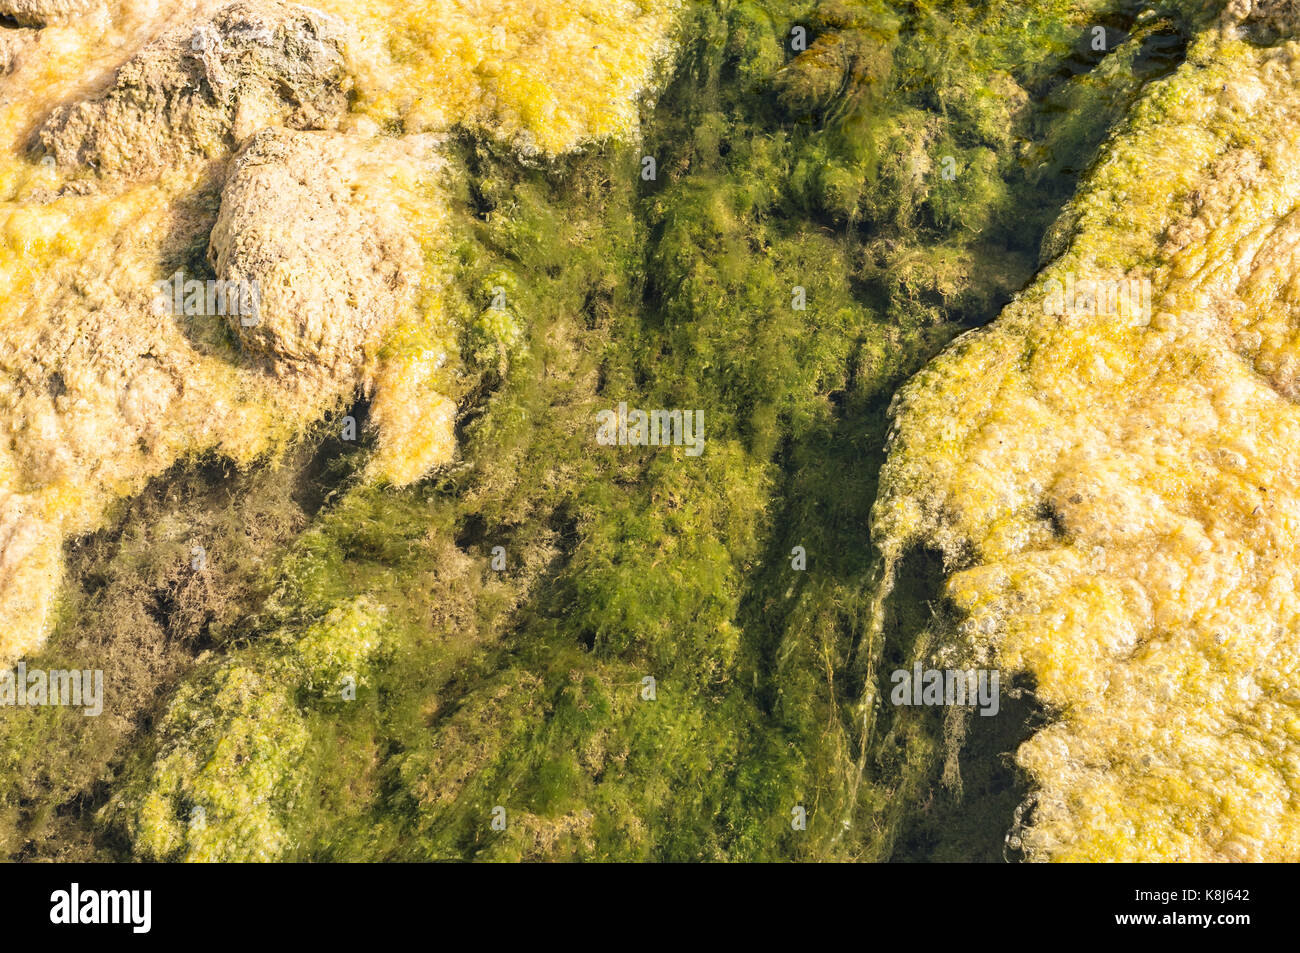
872;12;1300;861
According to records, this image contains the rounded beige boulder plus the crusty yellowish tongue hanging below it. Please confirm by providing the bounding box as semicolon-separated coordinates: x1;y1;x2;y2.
208;130;455;485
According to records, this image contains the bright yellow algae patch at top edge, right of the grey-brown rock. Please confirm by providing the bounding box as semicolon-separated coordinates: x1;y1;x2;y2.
316;0;681;155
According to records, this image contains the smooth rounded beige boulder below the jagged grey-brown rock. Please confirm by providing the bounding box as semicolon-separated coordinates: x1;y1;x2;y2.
208;129;423;380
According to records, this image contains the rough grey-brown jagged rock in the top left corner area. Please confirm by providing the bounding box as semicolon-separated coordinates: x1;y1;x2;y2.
39;0;351;178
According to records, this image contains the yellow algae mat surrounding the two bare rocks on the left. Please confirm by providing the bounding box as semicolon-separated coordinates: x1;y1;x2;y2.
0;0;679;659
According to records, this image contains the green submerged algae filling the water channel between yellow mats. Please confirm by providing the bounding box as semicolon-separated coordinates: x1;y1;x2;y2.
0;1;1196;861
